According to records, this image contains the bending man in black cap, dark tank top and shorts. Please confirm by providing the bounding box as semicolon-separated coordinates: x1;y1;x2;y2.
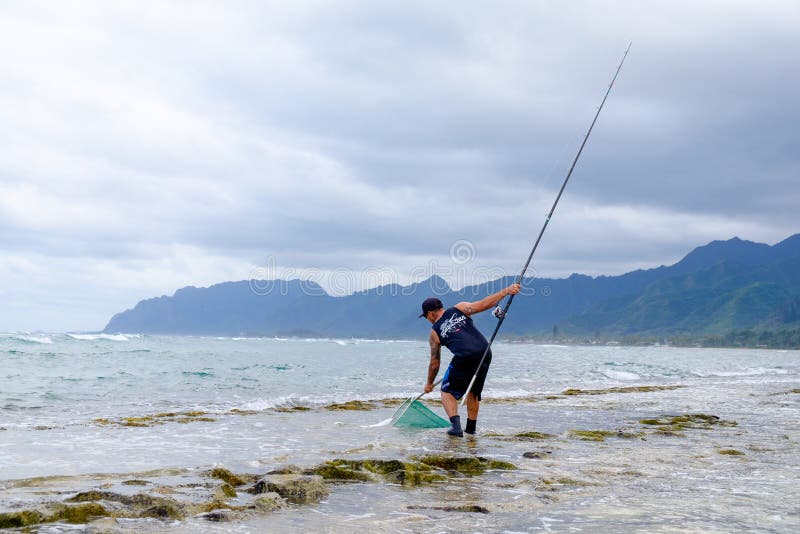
420;284;520;437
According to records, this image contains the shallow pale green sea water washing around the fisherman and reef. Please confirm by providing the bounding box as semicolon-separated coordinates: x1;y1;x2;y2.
0;334;800;532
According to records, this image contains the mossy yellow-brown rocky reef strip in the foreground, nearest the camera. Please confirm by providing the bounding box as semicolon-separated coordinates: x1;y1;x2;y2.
0;454;516;528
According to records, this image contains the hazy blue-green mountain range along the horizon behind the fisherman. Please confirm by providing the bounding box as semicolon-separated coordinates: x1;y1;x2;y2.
104;234;800;338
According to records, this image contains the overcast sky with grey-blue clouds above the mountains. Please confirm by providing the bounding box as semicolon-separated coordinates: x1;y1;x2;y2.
0;0;800;332
